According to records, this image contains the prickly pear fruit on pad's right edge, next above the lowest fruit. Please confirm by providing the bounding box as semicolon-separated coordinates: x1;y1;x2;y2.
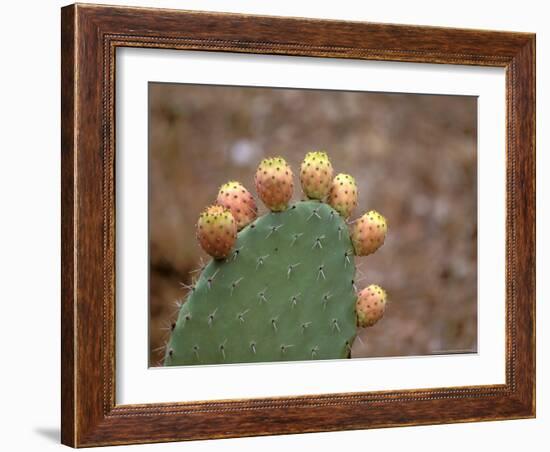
351;210;388;256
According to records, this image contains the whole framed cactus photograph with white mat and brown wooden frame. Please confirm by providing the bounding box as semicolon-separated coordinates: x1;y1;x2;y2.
61;4;535;447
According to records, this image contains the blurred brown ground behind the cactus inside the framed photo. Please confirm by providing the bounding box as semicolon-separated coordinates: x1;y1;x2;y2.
149;83;477;366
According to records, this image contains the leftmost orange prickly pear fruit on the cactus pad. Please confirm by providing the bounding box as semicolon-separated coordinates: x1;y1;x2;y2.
197;206;237;259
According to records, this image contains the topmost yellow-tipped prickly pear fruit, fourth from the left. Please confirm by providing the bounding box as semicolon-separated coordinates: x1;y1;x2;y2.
300;152;332;200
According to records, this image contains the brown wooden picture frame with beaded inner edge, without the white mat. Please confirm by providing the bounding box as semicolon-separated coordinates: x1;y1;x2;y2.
61;4;535;447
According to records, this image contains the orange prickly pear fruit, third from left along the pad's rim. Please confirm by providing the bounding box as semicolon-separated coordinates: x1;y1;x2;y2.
254;157;294;212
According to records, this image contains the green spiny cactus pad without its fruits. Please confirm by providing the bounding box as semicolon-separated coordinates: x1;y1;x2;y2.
164;201;357;366
